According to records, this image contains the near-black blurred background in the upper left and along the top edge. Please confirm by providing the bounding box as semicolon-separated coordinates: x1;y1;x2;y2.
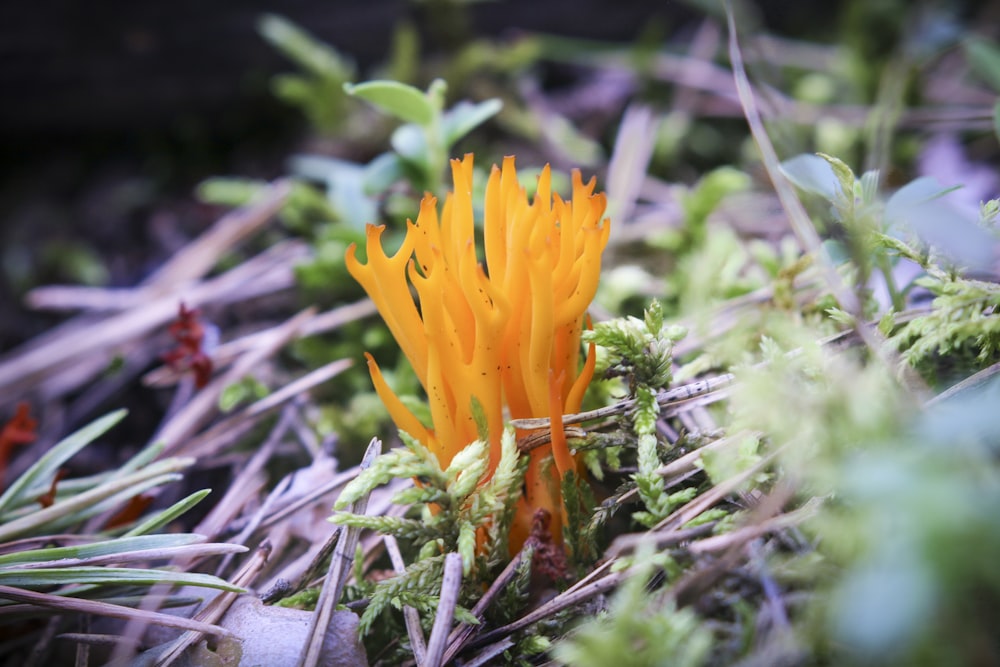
0;0;989;350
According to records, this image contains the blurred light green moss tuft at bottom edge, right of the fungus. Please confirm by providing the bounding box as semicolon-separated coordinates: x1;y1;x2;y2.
553;554;712;667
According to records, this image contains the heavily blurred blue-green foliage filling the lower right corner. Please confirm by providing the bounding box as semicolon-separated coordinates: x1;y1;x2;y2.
812;381;1000;666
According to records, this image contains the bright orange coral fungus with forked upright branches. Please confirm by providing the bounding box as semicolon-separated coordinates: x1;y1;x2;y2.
347;154;610;548
